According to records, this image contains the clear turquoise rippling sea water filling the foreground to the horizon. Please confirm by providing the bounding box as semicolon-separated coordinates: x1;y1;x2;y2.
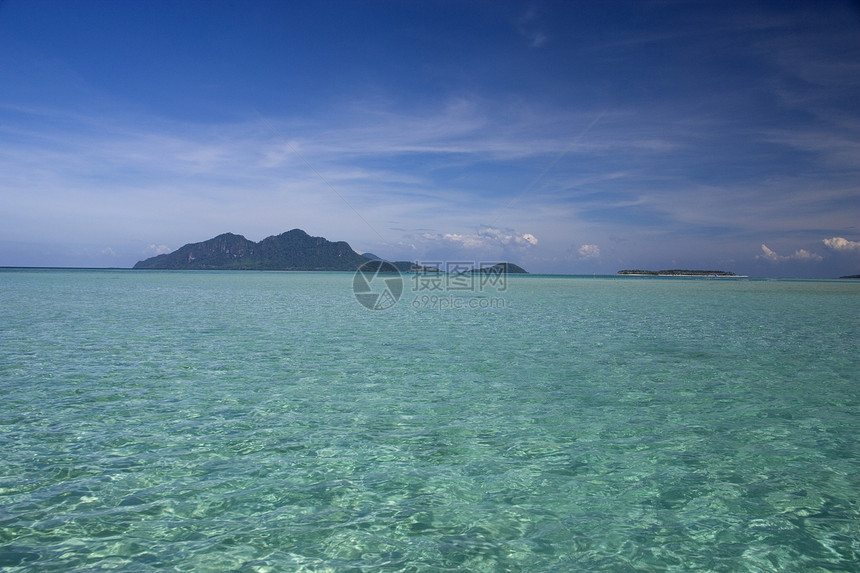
0;271;860;572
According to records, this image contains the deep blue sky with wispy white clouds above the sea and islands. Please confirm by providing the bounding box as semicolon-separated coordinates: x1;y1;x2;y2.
0;0;860;277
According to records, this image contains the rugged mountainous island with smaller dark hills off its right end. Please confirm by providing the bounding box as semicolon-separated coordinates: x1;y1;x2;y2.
133;229;526;273
